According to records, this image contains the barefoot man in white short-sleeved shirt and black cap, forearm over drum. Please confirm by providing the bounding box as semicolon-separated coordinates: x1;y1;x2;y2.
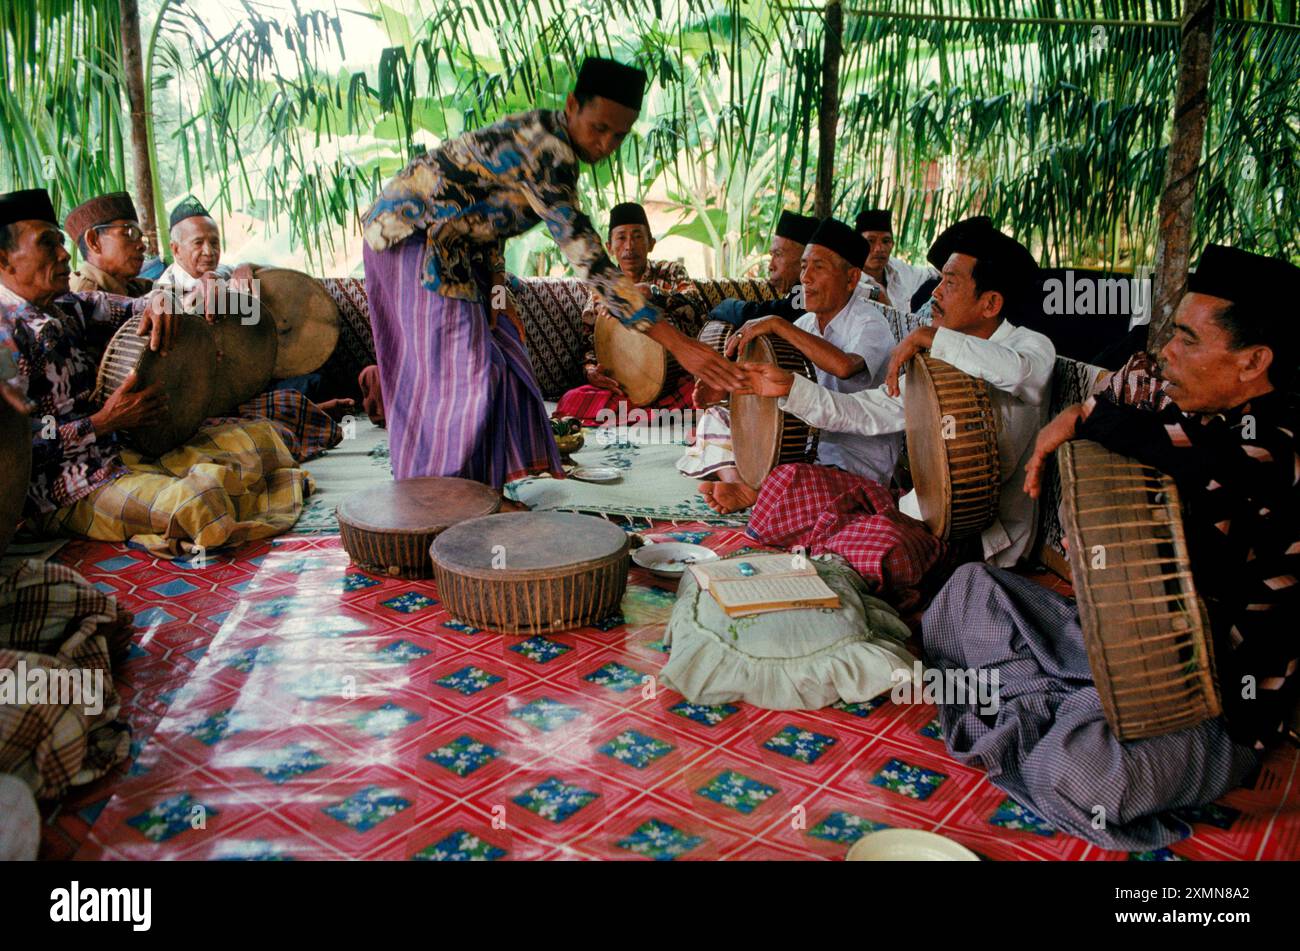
699;218;901;512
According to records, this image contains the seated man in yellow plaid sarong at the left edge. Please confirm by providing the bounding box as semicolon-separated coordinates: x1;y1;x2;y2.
0;190;311;556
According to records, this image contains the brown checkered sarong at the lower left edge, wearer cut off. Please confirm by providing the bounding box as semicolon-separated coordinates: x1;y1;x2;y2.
0;561;131;799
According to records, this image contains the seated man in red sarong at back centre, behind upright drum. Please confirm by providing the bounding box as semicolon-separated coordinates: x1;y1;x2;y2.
555;201;694;426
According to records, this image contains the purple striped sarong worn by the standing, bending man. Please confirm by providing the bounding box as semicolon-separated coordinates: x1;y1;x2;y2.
364;231;563;488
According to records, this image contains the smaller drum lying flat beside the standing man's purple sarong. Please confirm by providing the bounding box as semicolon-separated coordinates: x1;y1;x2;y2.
338;476;501;578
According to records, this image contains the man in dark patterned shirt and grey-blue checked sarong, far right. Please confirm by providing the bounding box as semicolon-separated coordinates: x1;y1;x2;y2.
923;244;1300;851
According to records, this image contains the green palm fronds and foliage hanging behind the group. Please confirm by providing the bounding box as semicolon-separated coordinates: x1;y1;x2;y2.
0;0;1300;274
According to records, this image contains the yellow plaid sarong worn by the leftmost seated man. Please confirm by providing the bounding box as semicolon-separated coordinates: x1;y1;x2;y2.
43;420;313;557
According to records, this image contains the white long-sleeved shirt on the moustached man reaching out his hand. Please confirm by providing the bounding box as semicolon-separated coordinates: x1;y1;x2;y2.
779;321;1056;568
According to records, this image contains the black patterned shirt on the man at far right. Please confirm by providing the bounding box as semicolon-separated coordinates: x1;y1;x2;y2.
1079;353;1300;748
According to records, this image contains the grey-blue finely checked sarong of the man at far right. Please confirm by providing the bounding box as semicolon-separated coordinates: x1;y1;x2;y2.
922;564;1260;851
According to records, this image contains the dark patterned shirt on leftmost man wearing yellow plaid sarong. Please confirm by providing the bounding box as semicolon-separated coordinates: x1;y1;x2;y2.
0;286;148;513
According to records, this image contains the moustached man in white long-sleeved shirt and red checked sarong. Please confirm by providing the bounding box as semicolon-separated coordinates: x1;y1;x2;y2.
733;218;1056;612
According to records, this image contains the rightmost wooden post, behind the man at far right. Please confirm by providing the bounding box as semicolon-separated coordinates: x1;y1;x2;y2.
1147;0;1214;353
